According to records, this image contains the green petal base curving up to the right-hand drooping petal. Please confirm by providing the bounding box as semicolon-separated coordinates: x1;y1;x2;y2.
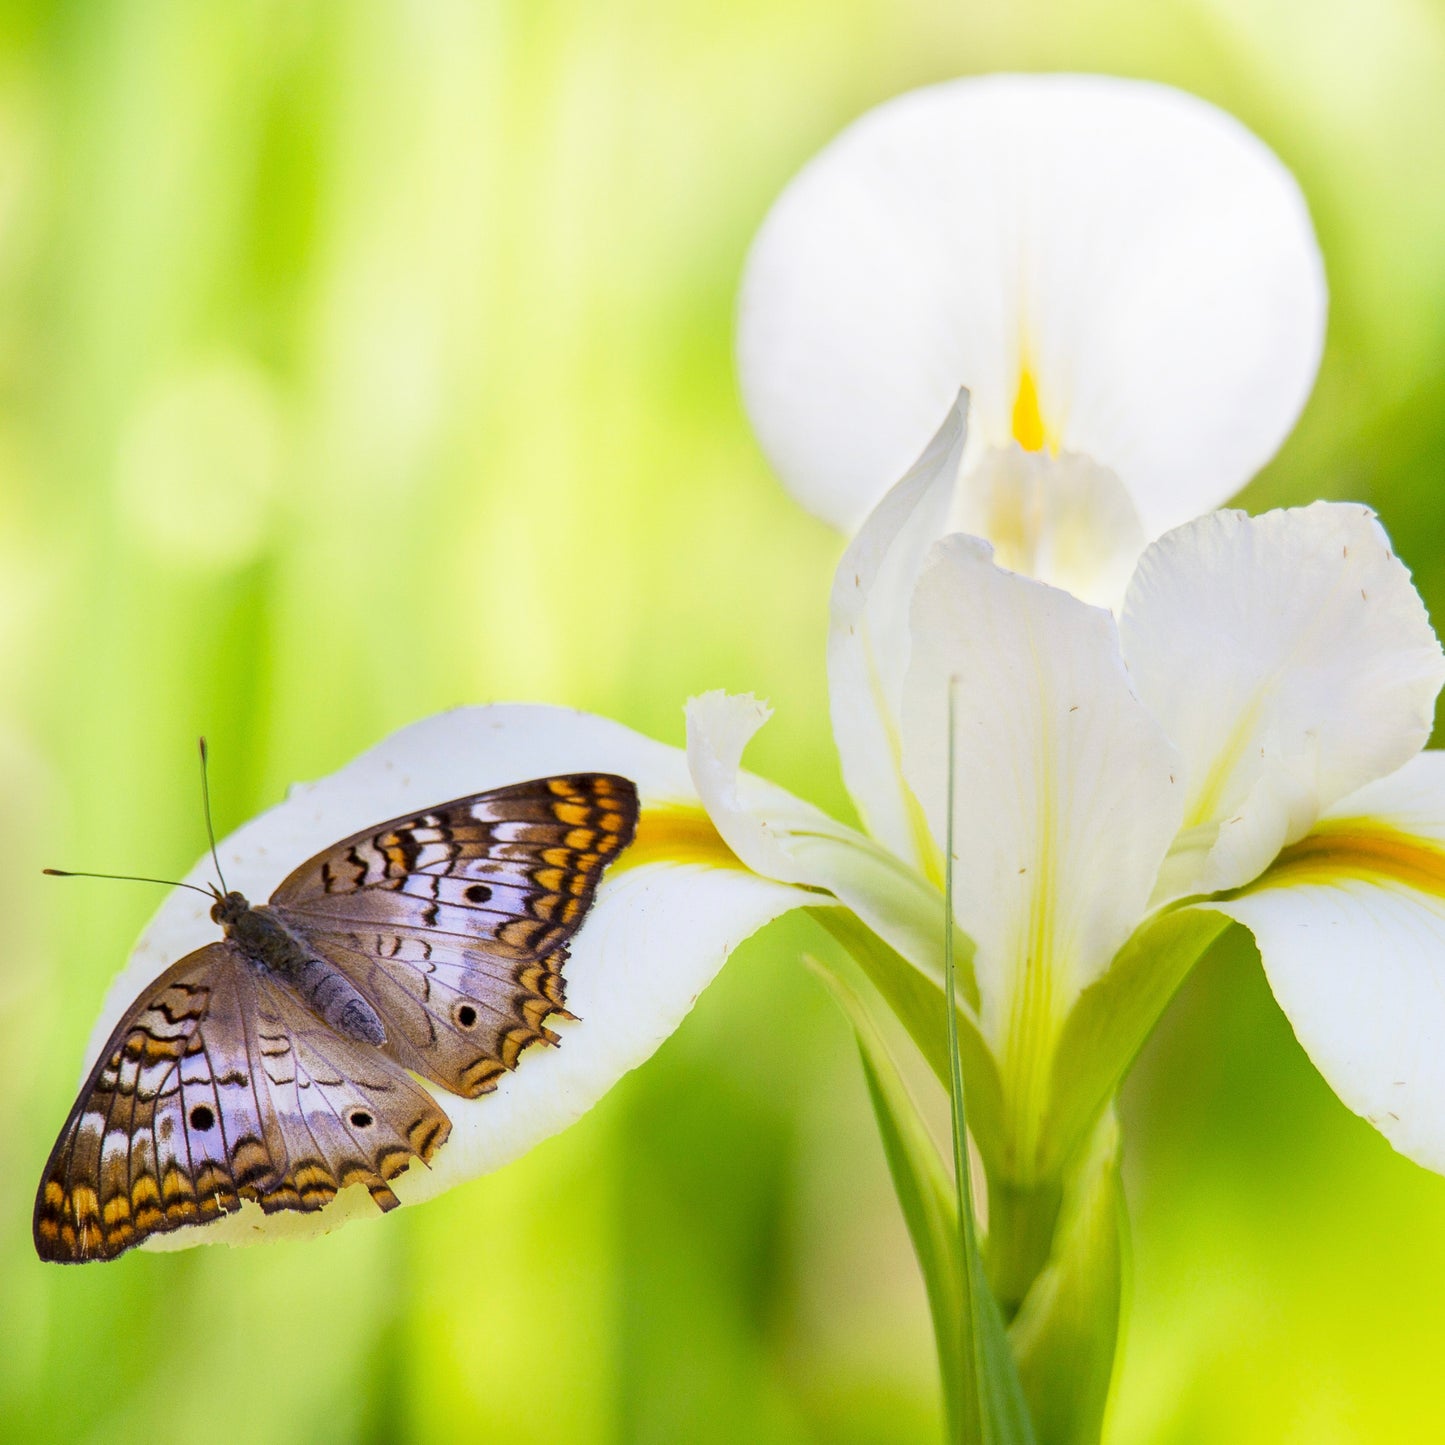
1039;907;1230;1179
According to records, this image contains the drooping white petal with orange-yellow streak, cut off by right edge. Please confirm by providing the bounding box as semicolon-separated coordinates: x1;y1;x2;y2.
1208;753;1445;1173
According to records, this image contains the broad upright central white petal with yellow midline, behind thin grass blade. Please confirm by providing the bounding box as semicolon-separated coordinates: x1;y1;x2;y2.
903;536;1183;1053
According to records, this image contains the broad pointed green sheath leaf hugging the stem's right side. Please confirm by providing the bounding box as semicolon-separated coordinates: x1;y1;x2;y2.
1009;1110;1127;1445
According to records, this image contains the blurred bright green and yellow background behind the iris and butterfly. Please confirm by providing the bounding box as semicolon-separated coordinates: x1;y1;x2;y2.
0;0;1445;1445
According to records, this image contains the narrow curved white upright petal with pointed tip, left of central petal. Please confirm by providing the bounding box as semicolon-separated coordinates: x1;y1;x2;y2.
828;393;968;877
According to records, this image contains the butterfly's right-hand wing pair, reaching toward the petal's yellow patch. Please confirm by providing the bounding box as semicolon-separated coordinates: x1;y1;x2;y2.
272;773;637;1098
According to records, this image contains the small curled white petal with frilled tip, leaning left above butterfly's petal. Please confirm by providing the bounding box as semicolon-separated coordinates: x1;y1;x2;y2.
688;692;962;980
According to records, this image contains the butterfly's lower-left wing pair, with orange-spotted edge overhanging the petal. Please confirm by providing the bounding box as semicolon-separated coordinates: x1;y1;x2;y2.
33;942;449;1263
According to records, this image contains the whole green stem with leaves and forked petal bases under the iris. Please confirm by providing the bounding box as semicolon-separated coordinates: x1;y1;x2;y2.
809;880;1230;1445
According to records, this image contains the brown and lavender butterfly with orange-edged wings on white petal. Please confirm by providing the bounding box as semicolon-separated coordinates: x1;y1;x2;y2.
33;773;637;1264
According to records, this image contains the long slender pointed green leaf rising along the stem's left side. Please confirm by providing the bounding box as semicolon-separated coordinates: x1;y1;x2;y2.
815;965;1035;1445
